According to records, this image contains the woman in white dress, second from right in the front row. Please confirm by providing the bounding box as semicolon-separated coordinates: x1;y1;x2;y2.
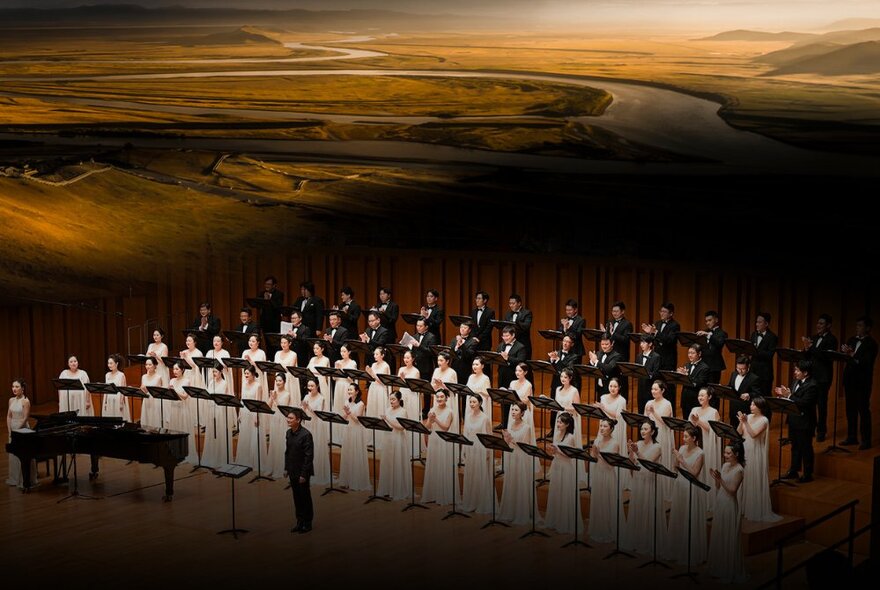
667;425;707;565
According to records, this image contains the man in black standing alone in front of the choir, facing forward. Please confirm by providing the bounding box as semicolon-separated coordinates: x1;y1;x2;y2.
284;408;315;534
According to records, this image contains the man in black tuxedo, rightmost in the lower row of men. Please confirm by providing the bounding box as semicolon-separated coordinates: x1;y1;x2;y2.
776;360;819;483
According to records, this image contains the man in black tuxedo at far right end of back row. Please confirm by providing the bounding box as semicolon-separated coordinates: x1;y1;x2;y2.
840;316;877;449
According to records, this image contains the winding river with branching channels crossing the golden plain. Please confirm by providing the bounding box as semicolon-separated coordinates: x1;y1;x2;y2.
0;37;876;175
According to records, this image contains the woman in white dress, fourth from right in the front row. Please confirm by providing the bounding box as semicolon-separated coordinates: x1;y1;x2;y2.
590;420;624;543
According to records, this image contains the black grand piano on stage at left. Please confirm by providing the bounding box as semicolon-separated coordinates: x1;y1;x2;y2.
6;412;189;502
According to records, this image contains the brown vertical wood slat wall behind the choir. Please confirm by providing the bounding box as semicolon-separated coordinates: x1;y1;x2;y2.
0;250;876;403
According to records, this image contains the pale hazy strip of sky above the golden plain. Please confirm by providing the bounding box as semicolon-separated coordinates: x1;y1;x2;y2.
0;0;880;31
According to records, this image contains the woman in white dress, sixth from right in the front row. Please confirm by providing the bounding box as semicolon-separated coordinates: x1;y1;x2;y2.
498;402;541;524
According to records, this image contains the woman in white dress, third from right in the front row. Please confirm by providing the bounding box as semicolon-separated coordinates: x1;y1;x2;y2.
620;420;667;555
